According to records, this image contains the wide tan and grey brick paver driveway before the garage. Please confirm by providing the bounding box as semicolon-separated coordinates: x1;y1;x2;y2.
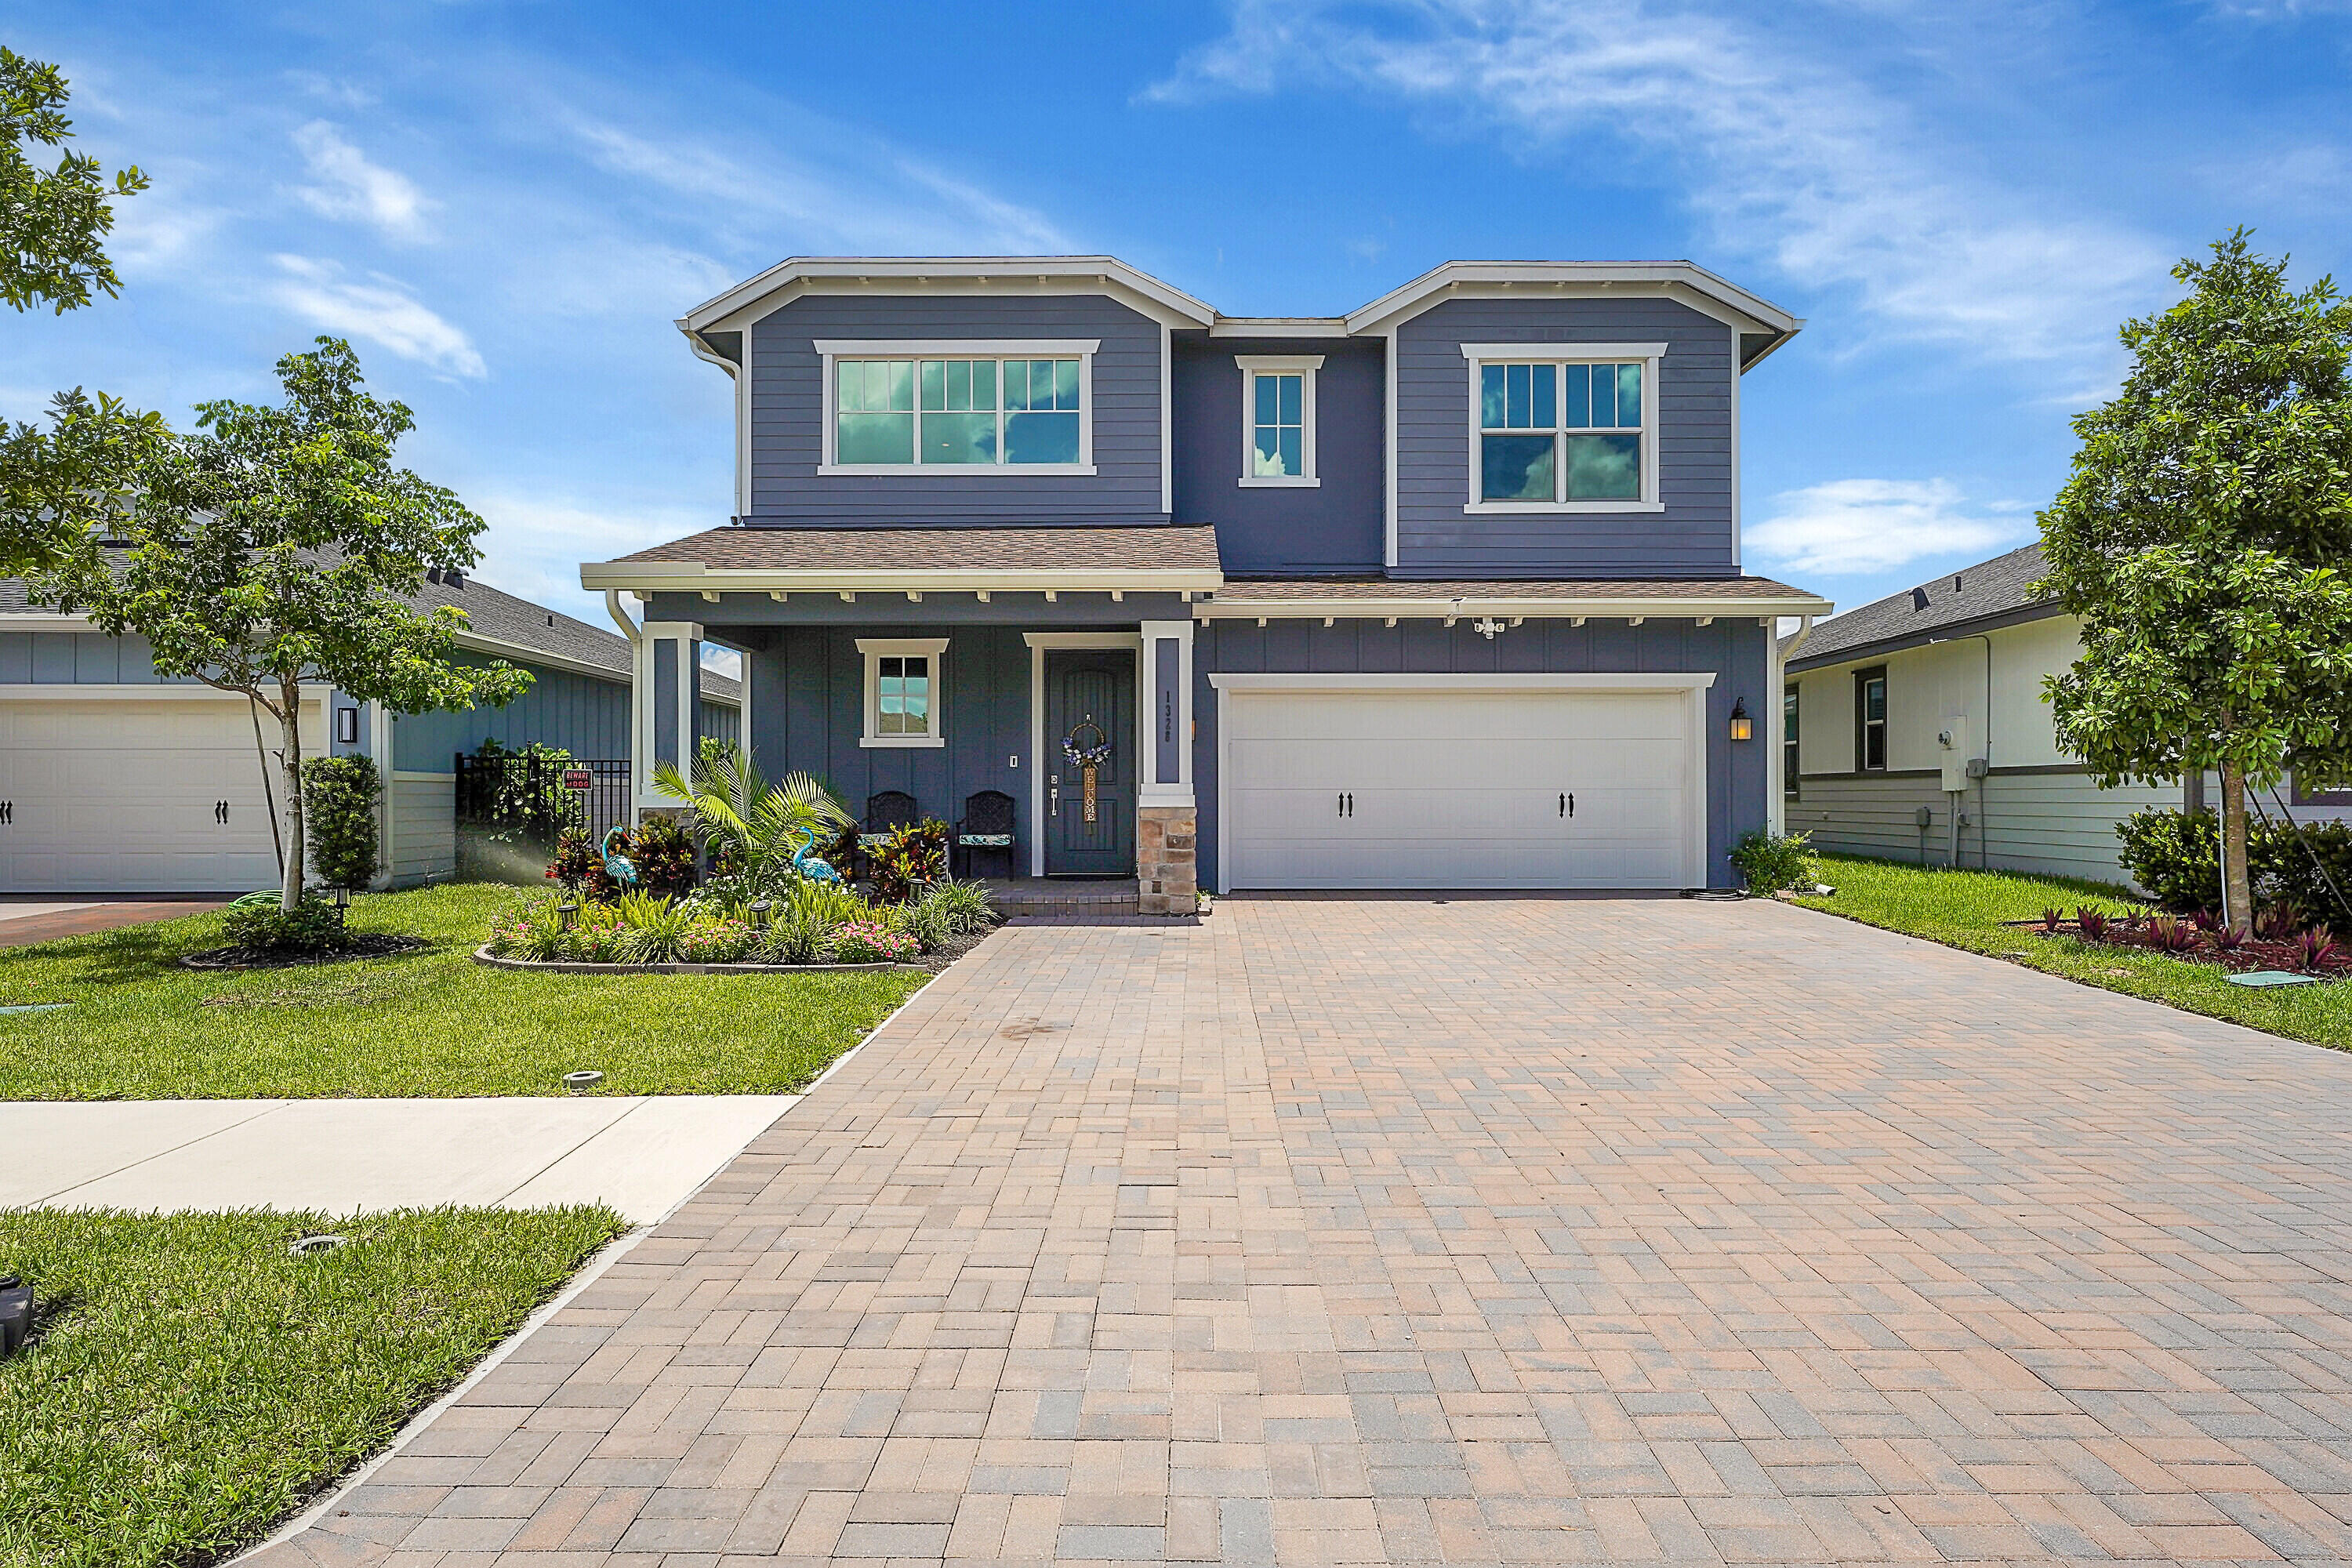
270;898;2352;1568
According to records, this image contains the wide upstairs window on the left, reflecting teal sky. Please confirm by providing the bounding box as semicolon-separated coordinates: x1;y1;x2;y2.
816;341;1096;475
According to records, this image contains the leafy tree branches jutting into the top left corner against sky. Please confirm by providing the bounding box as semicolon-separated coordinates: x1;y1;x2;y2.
0;45;148;315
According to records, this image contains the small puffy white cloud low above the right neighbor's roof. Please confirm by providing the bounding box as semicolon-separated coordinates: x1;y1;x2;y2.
1743;480;2032;576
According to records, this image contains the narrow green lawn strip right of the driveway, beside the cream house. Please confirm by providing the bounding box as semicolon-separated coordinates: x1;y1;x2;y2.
1797;855;2352;1048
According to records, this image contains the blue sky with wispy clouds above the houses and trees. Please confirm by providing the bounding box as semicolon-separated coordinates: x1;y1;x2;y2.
0;0;2352;630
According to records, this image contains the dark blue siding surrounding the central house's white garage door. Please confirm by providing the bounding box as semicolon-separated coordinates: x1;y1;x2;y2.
1192;616;1771;886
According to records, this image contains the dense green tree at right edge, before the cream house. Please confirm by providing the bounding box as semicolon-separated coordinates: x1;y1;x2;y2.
2042;228;2352;919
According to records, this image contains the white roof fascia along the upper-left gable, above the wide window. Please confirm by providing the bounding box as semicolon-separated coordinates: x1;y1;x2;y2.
677;256;1216;332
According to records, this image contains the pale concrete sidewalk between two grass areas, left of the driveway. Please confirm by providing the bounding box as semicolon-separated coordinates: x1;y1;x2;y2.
0;1095;800;1225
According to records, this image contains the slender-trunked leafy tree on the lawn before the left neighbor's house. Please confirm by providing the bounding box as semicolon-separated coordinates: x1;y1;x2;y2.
31;339;532;909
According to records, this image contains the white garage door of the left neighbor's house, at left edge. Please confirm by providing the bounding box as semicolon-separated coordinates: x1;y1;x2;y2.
0;699;320;893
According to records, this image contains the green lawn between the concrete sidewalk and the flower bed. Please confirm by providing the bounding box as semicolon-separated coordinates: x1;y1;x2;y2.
0;884;927;1100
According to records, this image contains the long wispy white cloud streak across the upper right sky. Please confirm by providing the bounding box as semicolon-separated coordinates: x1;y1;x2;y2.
1150;0;2171;362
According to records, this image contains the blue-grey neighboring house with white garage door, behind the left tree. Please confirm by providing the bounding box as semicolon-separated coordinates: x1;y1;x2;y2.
0;574;741;893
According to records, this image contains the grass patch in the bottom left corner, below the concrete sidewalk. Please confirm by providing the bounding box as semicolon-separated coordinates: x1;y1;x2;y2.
0;1208;626;1568
